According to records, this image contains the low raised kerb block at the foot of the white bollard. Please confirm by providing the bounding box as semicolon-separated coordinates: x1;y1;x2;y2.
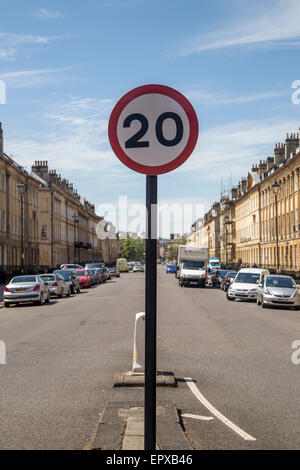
113;371;177;387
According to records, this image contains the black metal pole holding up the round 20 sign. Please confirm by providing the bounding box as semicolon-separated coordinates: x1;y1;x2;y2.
144;175;157;450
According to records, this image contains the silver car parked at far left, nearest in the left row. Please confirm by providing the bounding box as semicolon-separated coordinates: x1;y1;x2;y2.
3;275;50;307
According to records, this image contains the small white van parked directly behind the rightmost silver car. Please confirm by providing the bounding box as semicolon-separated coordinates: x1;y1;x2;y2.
226;268;270;300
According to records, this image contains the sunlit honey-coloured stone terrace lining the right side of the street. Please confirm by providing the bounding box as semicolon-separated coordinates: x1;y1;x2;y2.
189;129;300;277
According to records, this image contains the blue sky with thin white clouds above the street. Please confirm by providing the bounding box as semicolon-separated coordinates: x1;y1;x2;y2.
0;0;300;232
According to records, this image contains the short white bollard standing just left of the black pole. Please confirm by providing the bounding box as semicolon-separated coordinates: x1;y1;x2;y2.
132;312;145;375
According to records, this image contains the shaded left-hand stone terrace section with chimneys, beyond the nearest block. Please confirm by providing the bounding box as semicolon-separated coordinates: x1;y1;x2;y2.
31;161;102;270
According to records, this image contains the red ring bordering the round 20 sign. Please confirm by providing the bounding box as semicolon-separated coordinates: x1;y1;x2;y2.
108;85;199;175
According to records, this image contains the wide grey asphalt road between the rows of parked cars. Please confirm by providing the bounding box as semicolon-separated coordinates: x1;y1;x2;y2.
0;267;300;449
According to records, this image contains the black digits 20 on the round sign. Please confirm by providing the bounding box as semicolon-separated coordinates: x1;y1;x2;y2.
123;112;183;149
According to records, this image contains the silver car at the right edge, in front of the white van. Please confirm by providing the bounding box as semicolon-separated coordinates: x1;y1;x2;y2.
257;274;300;310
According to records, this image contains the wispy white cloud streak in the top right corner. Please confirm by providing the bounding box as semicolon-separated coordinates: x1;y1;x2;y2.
179;0;300;55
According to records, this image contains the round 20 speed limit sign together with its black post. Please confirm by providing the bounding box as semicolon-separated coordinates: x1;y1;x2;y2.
108;85;199;450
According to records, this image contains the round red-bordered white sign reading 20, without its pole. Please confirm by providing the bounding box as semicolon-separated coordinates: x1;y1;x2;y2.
108;85;199;175
